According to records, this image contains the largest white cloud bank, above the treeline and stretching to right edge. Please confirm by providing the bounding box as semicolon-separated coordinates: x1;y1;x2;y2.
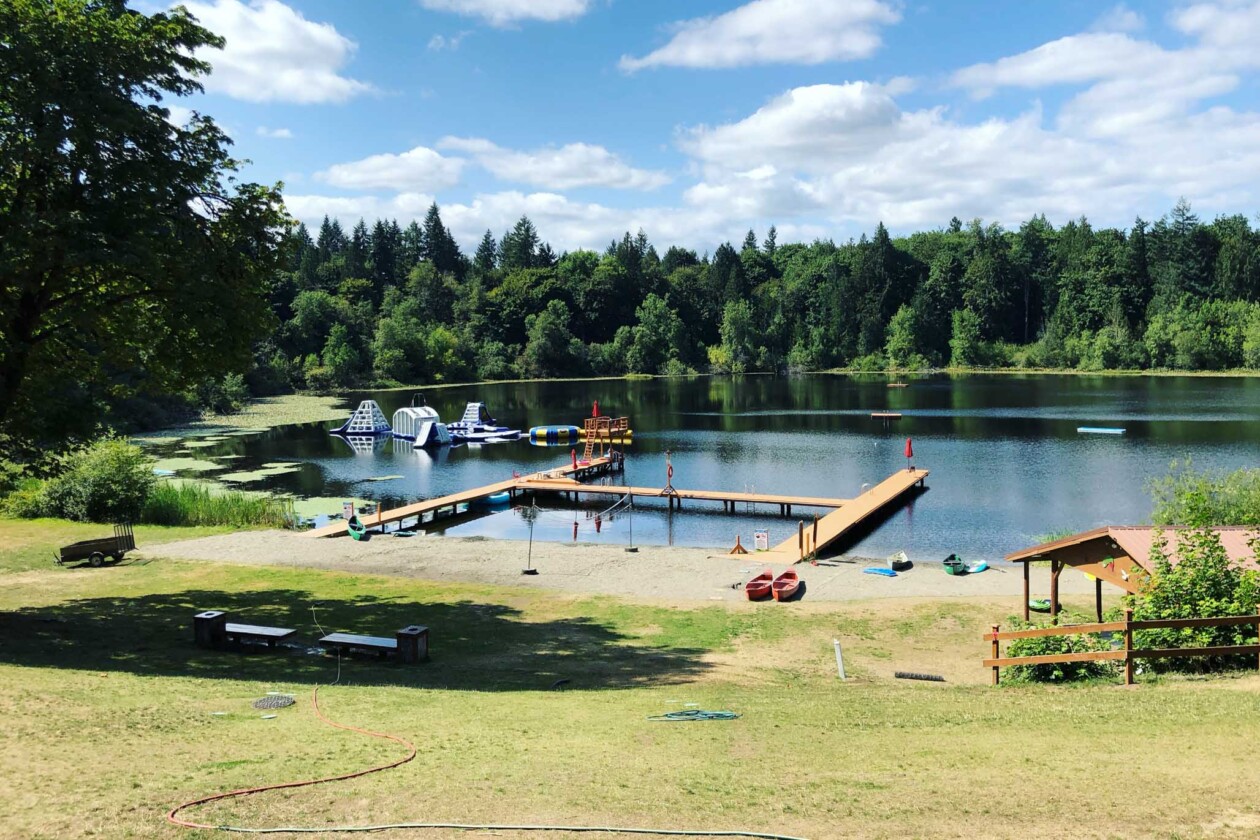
291;0;1260;251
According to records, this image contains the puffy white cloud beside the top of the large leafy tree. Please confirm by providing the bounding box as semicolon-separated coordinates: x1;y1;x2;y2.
183;0;373;103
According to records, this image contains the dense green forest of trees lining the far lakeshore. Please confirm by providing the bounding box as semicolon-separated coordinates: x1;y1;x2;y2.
260;201;1260;388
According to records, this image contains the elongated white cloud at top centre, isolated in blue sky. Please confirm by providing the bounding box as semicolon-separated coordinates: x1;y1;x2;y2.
621;0;901;72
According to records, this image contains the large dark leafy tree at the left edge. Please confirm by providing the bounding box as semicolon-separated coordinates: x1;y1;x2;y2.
0;0;286;437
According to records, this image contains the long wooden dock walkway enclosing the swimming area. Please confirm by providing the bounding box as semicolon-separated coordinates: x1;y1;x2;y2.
307;458;929;565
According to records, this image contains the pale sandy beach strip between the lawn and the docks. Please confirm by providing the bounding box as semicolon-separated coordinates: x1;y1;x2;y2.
146;531;1098;610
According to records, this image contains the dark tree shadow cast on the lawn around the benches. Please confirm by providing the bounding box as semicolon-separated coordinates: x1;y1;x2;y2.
0;589;709;691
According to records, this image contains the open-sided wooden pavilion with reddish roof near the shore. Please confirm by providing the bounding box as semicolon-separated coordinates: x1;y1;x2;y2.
1005;525;1260;621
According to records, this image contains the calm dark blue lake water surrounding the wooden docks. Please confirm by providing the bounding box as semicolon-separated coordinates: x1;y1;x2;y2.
167;375;1260;560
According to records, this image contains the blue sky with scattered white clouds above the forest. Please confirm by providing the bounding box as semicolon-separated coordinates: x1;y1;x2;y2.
154;0;1260;251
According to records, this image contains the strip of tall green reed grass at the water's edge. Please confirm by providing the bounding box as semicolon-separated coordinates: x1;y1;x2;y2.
140;481;294;528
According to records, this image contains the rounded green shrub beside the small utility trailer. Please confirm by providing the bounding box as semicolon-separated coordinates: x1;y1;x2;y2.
42;437;155;523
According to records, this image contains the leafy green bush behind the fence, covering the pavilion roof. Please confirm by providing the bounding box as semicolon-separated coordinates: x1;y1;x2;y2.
1129;528;1260;673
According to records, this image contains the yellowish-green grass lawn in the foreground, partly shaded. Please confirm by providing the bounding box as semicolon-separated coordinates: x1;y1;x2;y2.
0;520;1260;840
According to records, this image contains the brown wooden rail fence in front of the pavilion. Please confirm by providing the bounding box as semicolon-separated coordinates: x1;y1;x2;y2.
984;606;1260;685
